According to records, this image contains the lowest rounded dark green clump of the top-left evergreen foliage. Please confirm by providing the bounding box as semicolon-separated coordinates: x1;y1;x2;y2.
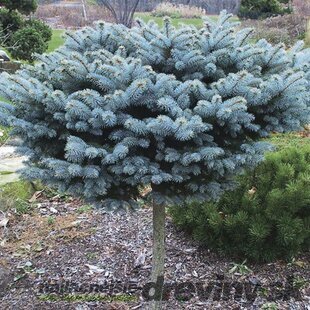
10;27;47;62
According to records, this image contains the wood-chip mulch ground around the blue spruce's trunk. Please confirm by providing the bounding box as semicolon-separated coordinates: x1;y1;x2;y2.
0;193;310;310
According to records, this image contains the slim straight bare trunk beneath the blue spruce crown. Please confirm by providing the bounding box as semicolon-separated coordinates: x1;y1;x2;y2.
151;203;166;310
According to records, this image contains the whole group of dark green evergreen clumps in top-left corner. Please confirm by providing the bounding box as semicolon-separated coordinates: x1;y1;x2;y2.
0;0;52;61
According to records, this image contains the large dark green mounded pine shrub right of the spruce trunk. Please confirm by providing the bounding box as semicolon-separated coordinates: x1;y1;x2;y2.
170;143;310;261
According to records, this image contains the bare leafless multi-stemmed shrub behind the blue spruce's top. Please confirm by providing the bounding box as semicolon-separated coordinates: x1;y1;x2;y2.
97;0;140;27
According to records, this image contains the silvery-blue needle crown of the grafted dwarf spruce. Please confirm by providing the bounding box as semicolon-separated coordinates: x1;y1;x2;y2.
0;12;310;208
